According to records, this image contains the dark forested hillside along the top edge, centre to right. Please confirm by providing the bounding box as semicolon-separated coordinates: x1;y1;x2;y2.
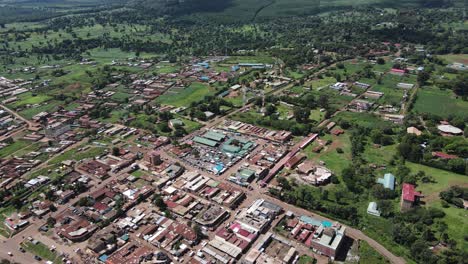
128;0;465;22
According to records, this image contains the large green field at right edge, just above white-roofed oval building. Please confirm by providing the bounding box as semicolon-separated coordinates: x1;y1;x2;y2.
413;87;468;117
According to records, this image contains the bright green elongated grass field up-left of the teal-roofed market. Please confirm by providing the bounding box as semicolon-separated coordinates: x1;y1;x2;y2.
156;83;214;107
